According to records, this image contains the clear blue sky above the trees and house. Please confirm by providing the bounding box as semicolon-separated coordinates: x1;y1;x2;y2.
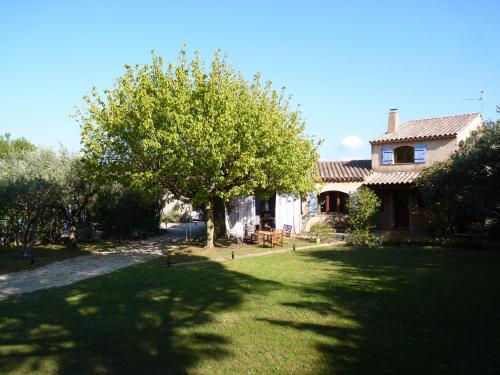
0;0;500;159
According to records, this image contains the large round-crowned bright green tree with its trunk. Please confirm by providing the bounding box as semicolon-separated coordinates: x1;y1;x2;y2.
79;50;318;247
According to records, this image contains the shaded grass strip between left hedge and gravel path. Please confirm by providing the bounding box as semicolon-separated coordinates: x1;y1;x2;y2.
0;240;123;274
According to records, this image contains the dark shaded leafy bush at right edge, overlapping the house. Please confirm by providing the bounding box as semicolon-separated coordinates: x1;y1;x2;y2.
418;121;500;237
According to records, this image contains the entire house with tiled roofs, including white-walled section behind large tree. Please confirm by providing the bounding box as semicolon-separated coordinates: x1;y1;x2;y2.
163;109;483;238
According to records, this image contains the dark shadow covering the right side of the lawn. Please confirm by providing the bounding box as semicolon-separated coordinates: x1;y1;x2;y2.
260;248;500;374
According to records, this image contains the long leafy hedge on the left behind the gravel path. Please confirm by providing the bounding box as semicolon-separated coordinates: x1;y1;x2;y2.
0;141;162;254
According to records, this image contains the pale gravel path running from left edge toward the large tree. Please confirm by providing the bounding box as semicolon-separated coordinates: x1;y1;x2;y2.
0;224;204;299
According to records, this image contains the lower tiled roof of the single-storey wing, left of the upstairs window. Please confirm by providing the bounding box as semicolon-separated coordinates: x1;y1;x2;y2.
318;160;372;182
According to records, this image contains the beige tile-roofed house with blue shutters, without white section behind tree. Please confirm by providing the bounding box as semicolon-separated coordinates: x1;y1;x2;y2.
305;109;483;231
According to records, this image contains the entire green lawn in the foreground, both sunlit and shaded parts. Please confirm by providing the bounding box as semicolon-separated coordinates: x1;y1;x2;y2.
0;248;500;374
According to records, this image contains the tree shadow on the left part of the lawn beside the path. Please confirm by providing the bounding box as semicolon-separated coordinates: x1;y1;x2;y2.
0;254;278;374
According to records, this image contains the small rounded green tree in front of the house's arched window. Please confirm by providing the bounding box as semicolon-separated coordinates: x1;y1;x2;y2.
347;187;381;234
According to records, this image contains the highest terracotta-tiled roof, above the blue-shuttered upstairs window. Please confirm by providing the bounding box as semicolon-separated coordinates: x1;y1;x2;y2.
370;113;481;144
